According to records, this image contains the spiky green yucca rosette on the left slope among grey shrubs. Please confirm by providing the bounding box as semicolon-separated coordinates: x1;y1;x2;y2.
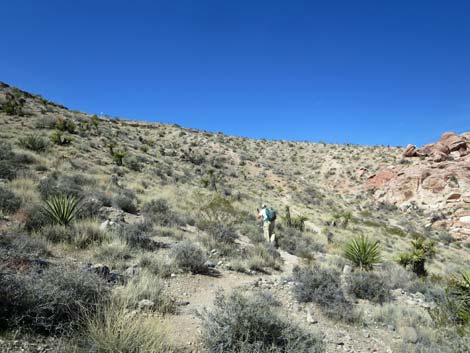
42;195;81;226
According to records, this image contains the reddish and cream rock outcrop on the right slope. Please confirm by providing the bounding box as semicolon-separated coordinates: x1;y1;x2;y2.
364;132;470;241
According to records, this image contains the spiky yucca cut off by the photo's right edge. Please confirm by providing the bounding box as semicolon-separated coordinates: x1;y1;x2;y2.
447;270;470;324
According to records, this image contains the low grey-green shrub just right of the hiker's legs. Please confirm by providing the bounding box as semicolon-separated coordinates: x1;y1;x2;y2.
276;227;324;258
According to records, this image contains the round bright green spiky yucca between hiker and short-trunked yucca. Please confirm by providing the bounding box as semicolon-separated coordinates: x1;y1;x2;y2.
344;235;381;271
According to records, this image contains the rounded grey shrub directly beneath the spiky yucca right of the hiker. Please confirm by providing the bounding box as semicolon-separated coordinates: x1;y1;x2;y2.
347;271;390;304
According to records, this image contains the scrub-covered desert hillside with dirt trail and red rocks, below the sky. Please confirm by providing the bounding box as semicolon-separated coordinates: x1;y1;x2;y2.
0;83;470;353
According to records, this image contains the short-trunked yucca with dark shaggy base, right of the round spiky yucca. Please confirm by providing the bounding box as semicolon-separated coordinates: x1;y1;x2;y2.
398;236;436;277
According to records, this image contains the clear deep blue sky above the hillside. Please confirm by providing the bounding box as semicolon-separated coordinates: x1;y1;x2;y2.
0;0;470;145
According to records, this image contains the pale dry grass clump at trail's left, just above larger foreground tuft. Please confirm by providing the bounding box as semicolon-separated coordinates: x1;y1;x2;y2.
118;271;176;314
